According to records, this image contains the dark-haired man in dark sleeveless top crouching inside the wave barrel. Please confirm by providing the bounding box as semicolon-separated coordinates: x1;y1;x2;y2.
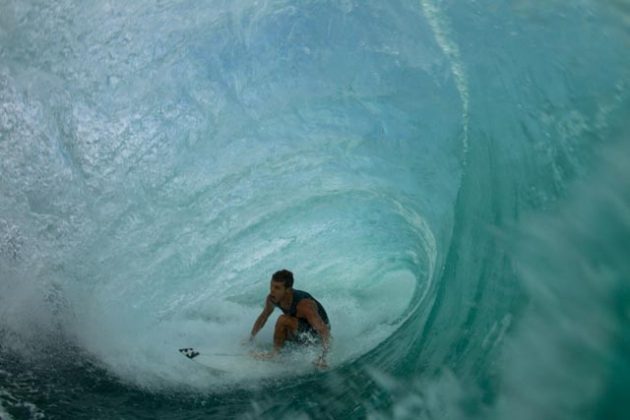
249;270;330;368
